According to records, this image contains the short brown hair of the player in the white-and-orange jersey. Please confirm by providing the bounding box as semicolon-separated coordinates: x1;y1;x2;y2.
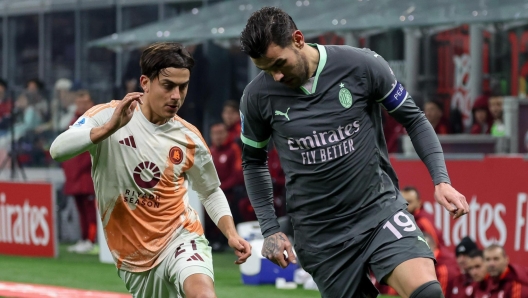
139;42;194;80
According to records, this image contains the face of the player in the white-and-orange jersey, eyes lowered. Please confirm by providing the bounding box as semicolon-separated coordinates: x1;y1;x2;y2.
141;67;191;119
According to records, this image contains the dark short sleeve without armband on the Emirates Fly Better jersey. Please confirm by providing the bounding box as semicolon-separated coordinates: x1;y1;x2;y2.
240;90;271;149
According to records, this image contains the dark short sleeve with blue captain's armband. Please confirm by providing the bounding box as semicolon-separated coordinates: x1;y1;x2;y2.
364;49;409;113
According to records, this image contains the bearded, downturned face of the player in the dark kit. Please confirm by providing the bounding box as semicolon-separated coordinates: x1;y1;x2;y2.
251;43;311;89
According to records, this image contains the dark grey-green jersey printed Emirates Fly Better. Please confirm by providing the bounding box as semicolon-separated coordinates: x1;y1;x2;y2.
240;45;444;249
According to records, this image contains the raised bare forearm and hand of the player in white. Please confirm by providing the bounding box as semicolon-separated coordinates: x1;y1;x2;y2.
90;92;143;144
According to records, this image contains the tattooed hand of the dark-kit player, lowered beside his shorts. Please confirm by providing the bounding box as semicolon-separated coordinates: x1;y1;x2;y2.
262;232;297;268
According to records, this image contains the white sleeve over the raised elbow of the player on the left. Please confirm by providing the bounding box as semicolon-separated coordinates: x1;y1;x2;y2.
50;127;94;161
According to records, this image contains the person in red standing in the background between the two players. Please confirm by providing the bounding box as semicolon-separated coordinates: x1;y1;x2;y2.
206;123;244;251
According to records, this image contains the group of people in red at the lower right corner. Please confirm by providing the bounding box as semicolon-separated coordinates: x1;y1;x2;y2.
378;186;528;298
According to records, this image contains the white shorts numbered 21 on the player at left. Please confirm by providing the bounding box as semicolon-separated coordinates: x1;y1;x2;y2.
118;233;214;298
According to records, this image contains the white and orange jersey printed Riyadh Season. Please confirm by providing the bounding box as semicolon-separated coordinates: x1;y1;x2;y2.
70;101;220;272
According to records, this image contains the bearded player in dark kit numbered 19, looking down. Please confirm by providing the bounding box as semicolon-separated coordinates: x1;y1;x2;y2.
240;7;469;298
